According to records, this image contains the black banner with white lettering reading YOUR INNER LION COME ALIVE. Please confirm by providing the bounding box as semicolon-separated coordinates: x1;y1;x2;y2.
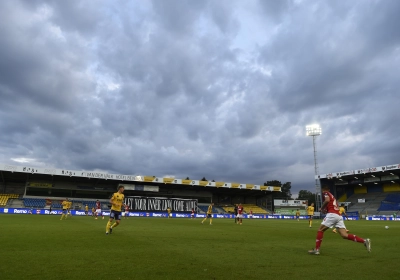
124;196;197;212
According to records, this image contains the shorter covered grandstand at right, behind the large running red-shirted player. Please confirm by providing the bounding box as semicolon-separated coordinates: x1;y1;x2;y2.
316;164;400;216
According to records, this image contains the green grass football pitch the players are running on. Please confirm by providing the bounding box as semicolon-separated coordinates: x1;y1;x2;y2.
0;215;400;280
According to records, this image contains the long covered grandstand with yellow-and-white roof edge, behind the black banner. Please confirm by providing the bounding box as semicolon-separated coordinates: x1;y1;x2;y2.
0;164;281;214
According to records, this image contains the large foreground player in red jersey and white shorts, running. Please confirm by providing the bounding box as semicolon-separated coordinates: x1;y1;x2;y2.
308;186;371;255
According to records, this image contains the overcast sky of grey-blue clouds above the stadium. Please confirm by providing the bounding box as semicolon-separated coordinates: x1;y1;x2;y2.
0;0;400;197
